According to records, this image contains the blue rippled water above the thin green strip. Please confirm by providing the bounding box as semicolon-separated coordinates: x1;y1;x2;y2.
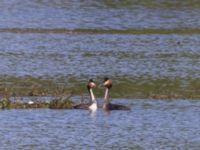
0;0;200;29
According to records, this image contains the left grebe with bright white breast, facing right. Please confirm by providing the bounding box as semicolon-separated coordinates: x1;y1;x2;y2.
73;79;97;111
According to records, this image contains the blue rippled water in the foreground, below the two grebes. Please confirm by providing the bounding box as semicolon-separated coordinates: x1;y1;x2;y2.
0;99;200;150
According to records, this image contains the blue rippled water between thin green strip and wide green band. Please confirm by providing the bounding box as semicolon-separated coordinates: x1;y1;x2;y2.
0;33;200;78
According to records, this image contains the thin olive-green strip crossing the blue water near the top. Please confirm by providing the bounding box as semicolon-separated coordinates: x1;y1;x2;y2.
0;28;200;34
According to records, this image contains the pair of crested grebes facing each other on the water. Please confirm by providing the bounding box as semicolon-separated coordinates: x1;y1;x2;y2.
74;77;130;111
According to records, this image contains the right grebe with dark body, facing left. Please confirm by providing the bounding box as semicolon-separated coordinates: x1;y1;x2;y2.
103;77;130;110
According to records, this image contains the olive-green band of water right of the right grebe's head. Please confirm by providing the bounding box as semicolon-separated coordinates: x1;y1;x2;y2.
110;77;200;99
